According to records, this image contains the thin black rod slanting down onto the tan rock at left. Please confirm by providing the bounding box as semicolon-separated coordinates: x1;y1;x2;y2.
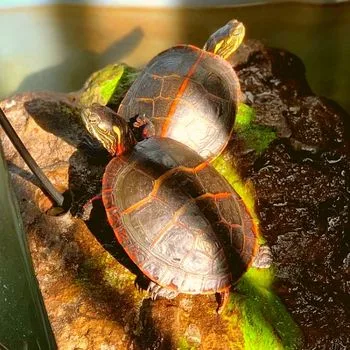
0;108;64;207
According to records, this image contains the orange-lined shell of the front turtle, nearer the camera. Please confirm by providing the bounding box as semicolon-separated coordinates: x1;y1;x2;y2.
102;138;257;294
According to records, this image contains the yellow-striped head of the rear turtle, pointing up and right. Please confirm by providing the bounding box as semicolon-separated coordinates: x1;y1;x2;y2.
203;19;245;59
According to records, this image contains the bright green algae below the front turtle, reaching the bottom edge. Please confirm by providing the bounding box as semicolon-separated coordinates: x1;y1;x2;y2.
235;268;302;350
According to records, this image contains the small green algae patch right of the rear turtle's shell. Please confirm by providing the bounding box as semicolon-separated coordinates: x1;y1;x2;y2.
234;103;276;154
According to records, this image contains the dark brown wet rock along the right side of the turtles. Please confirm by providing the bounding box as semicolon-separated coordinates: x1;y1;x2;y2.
225;40;350;349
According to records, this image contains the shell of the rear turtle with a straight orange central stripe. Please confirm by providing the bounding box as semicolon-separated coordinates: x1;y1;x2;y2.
118;45;240;159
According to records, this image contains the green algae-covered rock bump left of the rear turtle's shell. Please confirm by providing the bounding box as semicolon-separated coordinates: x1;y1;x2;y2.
80;63;137;106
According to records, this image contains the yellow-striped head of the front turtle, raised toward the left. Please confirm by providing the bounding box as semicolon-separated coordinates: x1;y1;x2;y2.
81;103;136;156
